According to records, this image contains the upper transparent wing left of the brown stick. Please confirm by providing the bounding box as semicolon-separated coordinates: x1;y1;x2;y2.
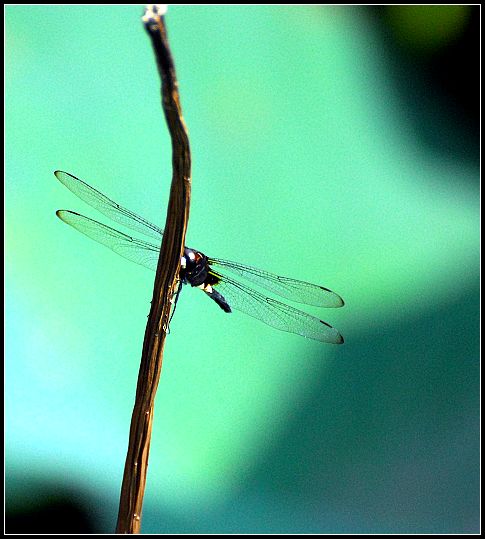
54;170;163;240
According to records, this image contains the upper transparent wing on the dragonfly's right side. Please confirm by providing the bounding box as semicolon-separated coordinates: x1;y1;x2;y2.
209;258;344;307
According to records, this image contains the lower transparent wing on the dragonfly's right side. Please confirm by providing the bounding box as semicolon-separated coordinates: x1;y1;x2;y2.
212;271;344;344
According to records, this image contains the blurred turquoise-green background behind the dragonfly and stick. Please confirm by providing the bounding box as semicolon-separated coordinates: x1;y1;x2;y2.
5;6;479;533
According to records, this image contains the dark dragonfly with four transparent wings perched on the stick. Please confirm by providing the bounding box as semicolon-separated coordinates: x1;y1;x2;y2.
54;170;344;344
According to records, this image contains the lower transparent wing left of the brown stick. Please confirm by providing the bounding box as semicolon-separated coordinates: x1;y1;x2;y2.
56;210;160;271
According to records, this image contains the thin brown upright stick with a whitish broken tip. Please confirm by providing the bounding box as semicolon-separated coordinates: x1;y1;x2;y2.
116;5;191;533
